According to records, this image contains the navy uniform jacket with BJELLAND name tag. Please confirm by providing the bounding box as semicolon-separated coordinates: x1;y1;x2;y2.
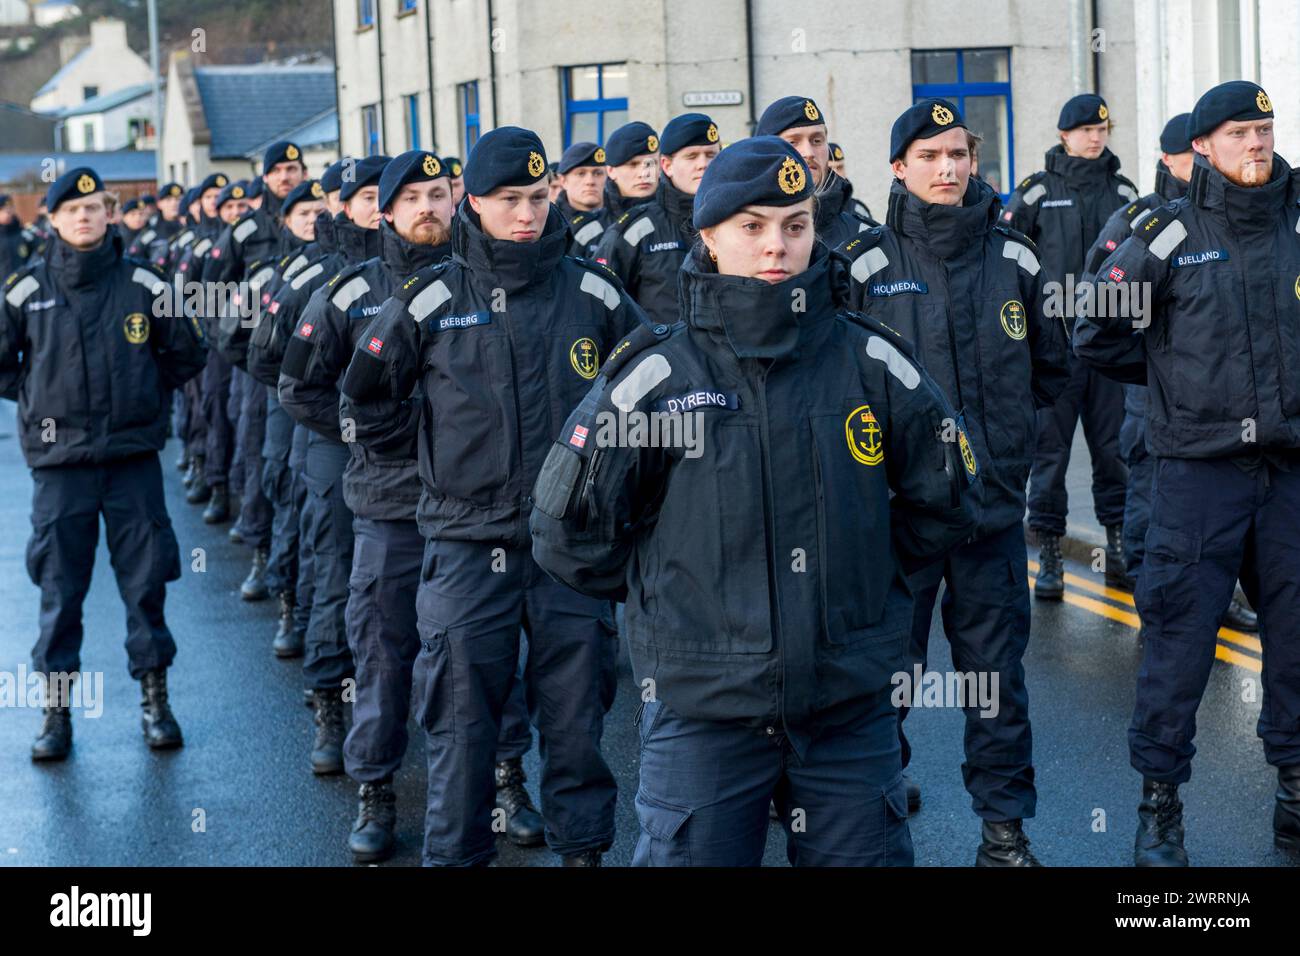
1074;156;1300;458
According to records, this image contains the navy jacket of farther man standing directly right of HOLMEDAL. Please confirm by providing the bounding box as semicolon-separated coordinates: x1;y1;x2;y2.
1002;144;1138;303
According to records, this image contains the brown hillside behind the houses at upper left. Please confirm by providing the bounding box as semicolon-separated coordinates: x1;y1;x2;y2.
0;0;332;105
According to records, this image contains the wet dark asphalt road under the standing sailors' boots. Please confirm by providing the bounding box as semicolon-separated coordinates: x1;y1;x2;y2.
0;402;1295;866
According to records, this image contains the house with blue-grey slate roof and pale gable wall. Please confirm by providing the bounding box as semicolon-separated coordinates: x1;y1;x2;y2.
163;52;338;183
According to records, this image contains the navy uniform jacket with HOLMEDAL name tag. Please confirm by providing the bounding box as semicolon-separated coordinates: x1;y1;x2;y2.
840;178;1069;537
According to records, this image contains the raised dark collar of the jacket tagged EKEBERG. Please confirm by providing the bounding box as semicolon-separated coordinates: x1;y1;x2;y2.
451;199;569;293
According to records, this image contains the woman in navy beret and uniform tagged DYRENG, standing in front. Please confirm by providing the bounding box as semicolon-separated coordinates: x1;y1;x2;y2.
532;137;971;866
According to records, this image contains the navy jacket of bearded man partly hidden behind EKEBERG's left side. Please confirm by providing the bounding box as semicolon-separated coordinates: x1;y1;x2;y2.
280;222;450;520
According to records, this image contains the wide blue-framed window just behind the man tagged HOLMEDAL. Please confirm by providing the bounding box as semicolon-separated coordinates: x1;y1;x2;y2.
911;48;1015;199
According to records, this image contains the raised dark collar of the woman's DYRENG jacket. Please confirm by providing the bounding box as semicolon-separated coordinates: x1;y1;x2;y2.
677;242;836;359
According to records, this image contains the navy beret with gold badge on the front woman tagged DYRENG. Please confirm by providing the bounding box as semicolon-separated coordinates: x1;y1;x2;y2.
692;137;813;229
